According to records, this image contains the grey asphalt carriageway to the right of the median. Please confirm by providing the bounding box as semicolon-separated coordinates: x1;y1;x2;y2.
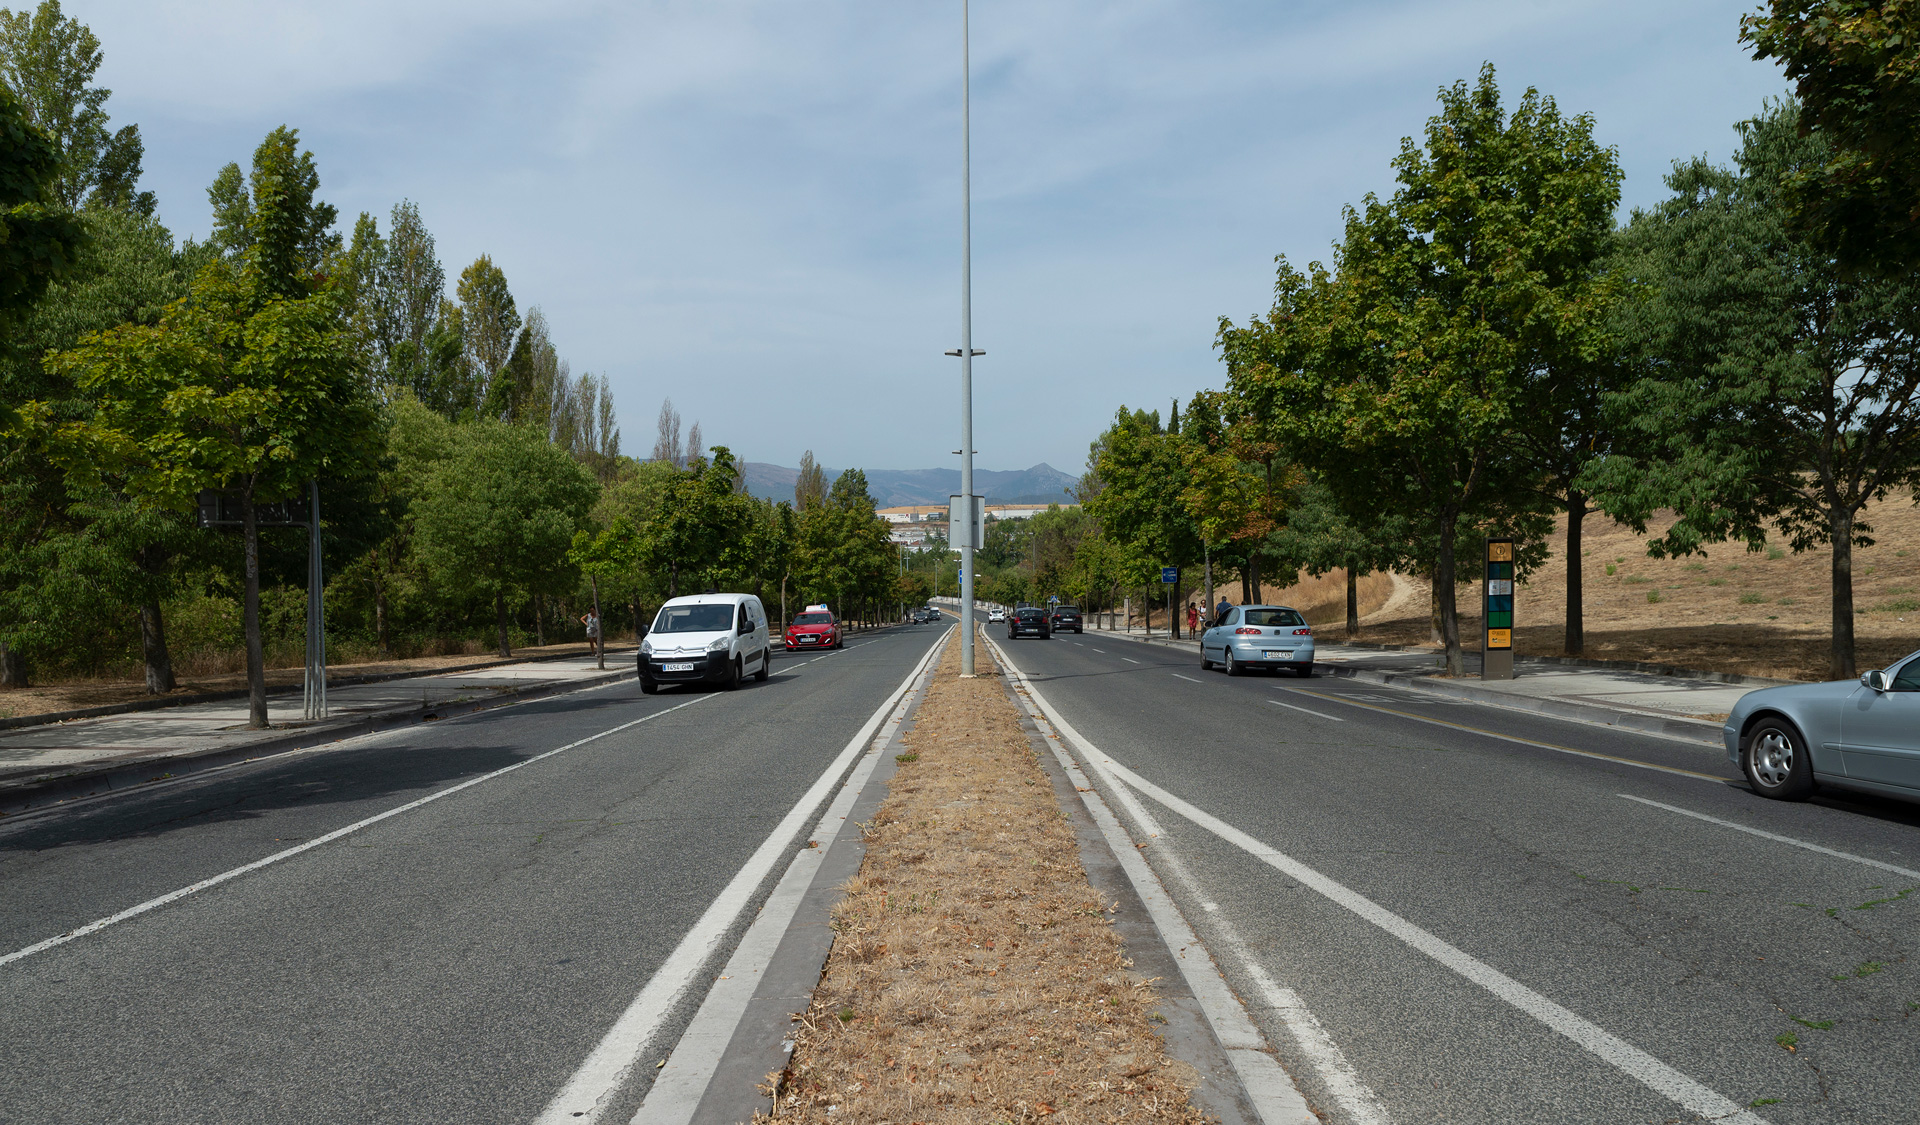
993;618;1920;1123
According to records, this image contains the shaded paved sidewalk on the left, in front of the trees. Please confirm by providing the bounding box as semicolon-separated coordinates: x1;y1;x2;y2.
0;651;634;816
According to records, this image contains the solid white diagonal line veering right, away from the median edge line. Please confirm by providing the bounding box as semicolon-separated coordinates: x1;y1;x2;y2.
1021;656;1766;1125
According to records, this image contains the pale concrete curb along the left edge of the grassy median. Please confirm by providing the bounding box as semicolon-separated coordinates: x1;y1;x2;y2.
632;637;947;1125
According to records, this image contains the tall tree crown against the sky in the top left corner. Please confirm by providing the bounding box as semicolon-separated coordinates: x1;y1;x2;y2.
0;0;154;215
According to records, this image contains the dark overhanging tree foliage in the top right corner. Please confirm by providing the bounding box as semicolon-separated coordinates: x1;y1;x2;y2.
1740;0;1920;275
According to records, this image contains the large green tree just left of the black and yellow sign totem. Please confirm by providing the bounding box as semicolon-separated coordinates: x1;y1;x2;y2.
1221;67;1617;664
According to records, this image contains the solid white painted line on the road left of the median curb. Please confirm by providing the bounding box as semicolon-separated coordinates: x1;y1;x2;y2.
534;625;939;1125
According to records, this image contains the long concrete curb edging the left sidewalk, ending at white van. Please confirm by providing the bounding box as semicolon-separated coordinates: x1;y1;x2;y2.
0;656;634;818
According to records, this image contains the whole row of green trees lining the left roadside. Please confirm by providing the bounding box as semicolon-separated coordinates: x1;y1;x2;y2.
0;0;897;722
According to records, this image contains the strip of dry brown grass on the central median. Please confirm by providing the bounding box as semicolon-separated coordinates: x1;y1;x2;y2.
774;633;1206;1125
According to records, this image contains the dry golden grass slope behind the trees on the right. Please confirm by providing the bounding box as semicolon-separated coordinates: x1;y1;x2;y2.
1361;487;1920;680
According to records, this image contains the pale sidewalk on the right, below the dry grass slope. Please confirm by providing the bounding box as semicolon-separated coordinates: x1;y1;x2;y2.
1087;618;1786;745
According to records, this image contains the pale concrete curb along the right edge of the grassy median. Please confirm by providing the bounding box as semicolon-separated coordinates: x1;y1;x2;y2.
987;629;1319;1125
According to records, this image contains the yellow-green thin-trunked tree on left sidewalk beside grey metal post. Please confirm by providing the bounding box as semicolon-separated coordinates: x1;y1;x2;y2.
36;127;378;728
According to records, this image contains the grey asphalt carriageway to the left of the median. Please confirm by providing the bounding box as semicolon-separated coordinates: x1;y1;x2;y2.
0;626;947;1125
